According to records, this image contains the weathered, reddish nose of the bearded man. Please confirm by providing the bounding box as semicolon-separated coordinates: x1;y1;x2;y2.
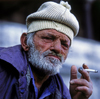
51;40;62;53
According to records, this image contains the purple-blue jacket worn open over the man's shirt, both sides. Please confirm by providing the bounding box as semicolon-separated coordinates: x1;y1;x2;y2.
0;45;71;99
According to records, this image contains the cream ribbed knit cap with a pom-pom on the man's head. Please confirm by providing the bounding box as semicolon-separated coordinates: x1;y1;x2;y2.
26;1;79;42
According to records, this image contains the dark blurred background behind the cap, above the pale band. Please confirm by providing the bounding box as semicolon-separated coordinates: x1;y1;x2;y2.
0;0;100;41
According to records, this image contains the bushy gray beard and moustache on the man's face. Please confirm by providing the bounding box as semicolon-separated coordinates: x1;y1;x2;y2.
28;43;64;75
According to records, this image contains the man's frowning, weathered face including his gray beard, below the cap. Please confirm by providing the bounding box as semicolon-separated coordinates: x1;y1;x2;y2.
28;29;70;75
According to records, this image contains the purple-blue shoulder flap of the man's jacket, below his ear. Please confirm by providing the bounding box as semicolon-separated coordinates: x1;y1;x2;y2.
0;45;27;72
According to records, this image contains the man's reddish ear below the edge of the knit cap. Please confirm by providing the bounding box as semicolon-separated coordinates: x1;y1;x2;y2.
20;33;29;51
